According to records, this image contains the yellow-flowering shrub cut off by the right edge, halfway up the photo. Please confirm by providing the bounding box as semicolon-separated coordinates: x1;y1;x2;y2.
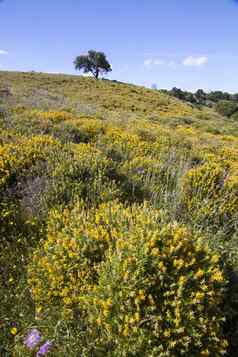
182;156;238;229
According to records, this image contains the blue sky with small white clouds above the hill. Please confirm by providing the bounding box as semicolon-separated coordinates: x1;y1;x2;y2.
0;0;238;92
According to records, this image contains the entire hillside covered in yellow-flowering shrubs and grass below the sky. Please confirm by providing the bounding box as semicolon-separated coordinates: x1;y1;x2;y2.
0;72;238;357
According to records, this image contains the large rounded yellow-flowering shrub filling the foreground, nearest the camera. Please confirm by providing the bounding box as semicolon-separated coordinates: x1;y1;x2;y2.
28;202;227;357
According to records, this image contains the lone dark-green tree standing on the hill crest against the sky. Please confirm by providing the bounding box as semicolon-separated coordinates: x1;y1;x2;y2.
74;50;112;79
